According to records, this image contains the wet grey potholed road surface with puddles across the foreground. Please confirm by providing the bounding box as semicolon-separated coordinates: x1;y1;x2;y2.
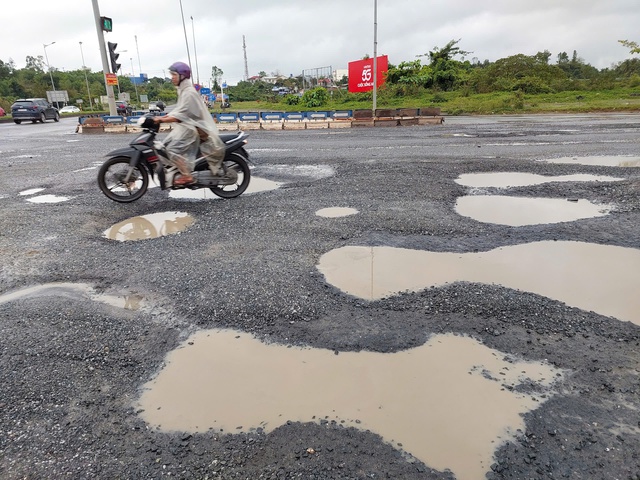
0;114;640;480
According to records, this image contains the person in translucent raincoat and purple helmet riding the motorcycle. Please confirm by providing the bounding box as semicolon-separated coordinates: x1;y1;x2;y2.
153;62;225;185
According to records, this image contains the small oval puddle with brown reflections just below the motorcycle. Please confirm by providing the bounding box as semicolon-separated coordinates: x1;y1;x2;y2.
103;212;194;242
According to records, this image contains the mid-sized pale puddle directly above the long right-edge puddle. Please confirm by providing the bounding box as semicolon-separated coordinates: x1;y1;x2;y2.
455;195;612;227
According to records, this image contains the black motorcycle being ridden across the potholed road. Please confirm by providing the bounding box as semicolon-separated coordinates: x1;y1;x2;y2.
98;117;251;203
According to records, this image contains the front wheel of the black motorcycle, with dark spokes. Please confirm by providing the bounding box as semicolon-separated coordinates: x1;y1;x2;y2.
98;157;149;203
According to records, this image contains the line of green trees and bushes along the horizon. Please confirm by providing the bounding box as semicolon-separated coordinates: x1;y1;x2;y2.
0;40;640;109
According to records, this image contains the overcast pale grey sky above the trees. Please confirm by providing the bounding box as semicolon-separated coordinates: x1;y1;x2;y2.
0;0;640;85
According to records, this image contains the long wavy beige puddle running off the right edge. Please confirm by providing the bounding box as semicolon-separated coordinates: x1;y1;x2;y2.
318;241;640;325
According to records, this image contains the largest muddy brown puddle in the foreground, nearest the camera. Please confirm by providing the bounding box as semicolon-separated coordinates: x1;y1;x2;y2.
138;330;561;480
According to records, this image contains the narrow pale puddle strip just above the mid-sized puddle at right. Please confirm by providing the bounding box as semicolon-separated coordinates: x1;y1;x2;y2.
455;172;624;188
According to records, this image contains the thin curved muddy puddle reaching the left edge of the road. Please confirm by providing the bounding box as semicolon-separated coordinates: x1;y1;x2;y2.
0;282;146;311
